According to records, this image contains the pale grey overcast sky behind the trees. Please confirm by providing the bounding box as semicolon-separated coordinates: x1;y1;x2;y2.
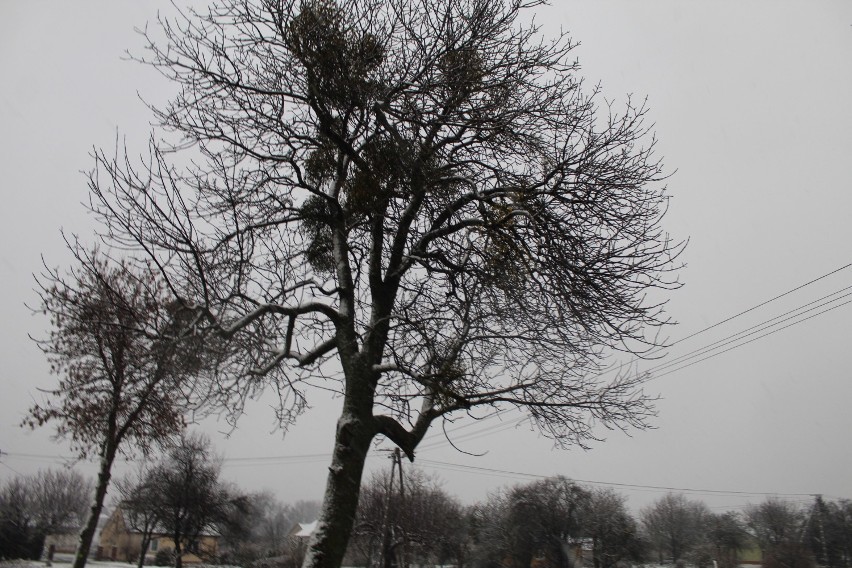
0;0;852;510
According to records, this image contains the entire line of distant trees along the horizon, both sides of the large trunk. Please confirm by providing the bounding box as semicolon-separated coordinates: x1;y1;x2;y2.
6;448;852;568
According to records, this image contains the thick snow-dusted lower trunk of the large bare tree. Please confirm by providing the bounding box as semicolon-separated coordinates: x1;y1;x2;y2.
302;403;375;568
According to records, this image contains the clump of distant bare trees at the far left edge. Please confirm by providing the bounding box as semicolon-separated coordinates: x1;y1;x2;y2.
0;470;92;560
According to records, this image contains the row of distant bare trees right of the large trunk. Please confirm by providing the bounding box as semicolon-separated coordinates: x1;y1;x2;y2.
349;469;852;568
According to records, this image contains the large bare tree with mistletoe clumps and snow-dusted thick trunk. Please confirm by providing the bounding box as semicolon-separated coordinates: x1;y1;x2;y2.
90;0;680;567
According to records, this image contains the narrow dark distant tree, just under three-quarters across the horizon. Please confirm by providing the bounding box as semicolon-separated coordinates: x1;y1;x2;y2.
581;489;645;568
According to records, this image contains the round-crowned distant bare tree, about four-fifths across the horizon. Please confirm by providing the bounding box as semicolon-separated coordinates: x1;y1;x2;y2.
640;493;710;562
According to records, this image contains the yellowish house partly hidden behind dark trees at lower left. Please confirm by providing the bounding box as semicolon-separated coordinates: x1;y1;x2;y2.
97;507;219;564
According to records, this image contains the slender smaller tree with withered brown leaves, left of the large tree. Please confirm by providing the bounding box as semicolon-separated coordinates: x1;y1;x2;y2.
23;244;207;568
